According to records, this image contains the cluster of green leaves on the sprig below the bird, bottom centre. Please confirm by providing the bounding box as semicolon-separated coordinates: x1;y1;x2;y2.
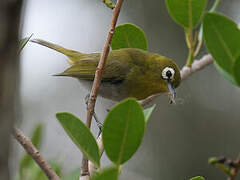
56;98;155;179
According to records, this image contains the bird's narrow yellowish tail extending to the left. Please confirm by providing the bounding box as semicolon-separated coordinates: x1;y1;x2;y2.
30;39;84;59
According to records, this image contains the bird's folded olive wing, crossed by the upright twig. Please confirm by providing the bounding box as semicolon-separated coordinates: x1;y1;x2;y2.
54;58;129;83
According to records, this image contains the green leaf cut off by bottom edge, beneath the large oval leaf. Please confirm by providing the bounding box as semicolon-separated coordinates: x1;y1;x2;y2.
91;167;118;180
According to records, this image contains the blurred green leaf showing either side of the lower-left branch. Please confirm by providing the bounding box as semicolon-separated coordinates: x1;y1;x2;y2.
19;124;43;175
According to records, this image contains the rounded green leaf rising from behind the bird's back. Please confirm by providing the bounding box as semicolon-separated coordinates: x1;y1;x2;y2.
111;23;148;50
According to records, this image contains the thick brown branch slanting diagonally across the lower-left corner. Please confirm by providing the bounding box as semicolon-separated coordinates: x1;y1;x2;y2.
13;127;60;180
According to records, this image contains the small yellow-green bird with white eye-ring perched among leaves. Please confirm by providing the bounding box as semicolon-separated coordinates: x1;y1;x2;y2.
31;39;181;101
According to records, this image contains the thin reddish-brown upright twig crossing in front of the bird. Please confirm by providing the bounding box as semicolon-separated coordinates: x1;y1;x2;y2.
80;0;123;179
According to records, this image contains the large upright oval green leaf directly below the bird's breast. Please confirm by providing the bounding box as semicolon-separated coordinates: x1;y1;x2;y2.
102;98;145;165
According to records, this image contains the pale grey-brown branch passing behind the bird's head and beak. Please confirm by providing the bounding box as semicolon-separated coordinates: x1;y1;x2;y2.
139;54;213;106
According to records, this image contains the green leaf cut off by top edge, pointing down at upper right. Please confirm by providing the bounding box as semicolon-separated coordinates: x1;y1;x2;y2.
165;0;206;29
